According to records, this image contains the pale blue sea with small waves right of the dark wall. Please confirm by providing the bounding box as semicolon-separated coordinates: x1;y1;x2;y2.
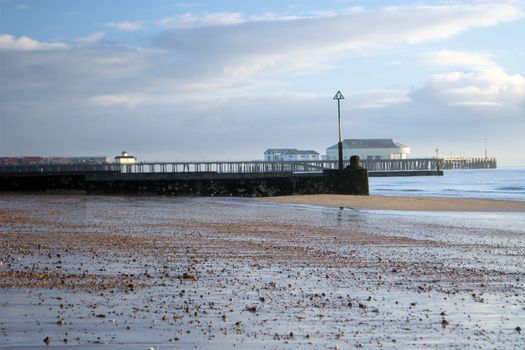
369;167;525;201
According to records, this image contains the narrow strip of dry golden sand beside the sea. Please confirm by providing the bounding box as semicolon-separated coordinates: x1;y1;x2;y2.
259;194;525;213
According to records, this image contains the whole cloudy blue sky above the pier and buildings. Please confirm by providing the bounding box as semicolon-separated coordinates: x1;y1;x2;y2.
0;0;525;166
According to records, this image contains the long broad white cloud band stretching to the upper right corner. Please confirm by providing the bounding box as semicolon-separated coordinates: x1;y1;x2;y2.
153;4;523;78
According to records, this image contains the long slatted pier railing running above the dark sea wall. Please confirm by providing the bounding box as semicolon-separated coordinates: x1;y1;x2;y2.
0;158;472;174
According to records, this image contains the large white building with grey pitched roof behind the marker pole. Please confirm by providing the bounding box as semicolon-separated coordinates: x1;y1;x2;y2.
326;139;410;160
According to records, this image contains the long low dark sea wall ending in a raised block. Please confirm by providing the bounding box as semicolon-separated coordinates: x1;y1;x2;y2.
0;169;369;197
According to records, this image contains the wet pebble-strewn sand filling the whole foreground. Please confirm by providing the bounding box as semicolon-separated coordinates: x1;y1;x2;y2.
0;195;525;349
